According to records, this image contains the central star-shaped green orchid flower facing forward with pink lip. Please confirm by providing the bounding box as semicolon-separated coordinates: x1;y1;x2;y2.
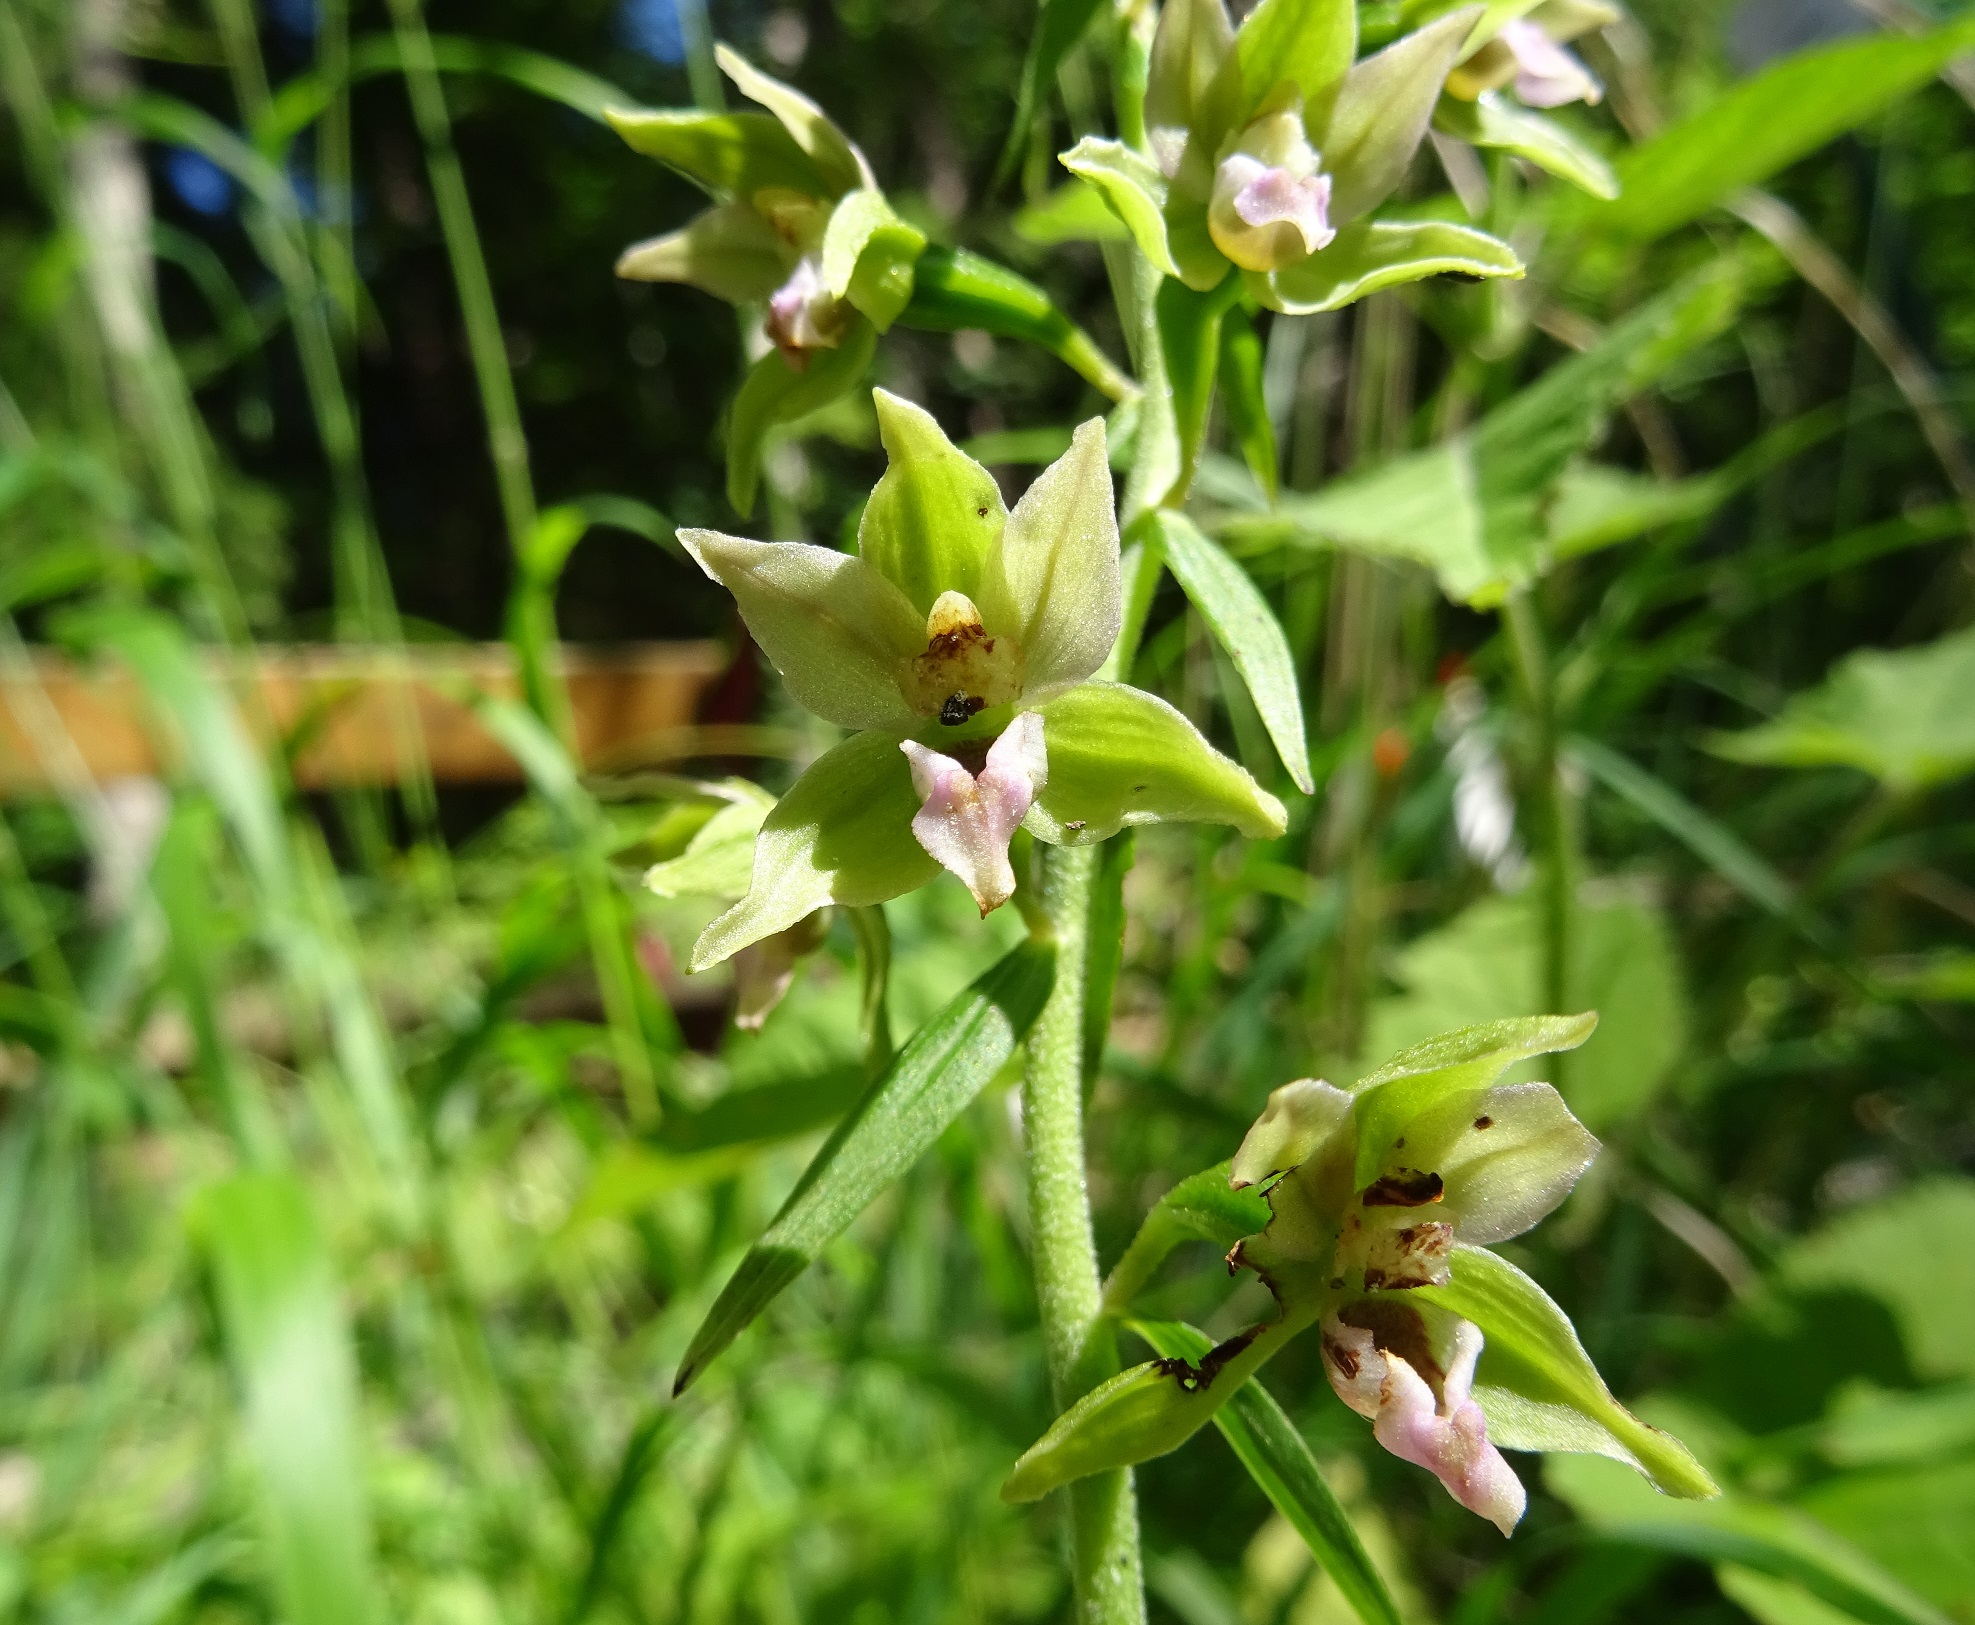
679;389;1286;969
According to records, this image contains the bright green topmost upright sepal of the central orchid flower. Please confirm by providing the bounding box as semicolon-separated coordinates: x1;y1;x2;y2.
857;389;1015;616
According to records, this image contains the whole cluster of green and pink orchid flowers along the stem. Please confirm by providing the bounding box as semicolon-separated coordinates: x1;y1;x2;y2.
614;0;1712;1532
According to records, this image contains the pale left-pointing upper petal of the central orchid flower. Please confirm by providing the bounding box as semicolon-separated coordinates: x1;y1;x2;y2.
679;531;926;731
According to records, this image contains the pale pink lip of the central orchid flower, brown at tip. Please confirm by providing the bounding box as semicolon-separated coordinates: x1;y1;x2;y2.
899;711;1049;914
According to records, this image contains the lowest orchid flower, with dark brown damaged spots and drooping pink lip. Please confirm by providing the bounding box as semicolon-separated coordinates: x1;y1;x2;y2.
1001;1015;1716;1534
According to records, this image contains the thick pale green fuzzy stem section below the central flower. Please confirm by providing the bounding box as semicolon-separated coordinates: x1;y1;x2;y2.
1021;847;1146;1625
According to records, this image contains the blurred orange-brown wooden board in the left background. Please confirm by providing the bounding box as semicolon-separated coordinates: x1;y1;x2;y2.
0;642;727;794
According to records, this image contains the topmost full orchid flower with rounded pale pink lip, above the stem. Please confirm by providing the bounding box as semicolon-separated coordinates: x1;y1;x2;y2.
1063;0;1523;314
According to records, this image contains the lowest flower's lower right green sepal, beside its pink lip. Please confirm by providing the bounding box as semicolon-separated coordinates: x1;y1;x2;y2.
1412;1246;1720;1499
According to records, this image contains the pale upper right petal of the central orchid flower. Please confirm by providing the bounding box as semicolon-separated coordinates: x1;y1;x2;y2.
978;417;1124;701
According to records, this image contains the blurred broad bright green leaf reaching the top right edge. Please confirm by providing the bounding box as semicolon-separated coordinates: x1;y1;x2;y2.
1574;18;1975;239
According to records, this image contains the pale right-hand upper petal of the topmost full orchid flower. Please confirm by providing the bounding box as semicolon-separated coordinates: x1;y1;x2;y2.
1311;6;1481;226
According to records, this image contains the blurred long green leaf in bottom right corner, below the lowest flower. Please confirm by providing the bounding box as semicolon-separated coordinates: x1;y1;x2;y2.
1548;1453;1947;1625
